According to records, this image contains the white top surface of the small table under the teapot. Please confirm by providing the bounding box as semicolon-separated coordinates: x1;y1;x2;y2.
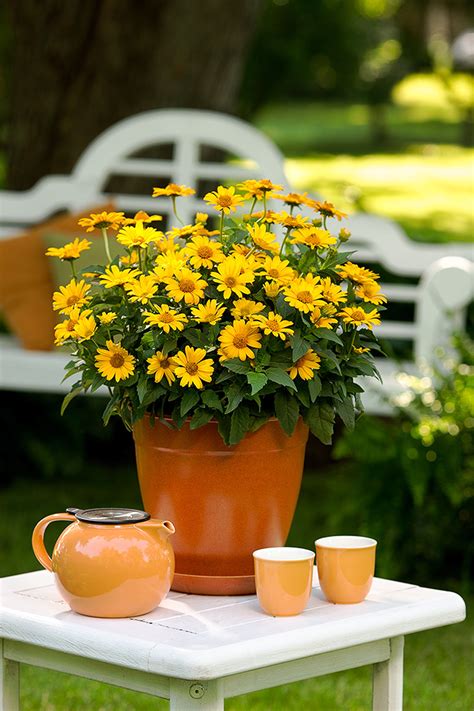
0;570;465;679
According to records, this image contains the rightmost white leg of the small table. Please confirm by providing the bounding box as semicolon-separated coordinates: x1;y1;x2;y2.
372;637;404;711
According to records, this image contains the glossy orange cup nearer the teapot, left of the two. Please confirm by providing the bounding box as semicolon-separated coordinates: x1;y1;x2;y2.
253;547;314;617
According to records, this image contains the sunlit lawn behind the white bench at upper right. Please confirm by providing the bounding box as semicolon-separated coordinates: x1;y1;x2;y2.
256;104;474;242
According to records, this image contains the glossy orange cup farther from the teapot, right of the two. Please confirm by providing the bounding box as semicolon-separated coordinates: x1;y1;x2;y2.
315;536;377;605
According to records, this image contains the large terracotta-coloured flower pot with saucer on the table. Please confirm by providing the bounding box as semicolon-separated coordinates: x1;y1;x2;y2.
134;418;308;595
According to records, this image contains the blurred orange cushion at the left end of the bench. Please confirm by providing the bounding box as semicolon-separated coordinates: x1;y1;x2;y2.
0;204;115;351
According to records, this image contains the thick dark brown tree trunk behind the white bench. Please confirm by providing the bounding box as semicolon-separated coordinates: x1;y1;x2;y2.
7;0;261;189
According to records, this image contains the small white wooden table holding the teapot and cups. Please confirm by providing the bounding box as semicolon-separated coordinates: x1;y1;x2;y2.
0;571;465;711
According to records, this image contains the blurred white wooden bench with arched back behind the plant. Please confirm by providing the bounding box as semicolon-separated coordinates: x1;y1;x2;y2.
0;110;473;413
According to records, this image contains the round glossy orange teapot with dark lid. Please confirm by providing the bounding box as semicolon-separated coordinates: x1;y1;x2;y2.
32;508;175;617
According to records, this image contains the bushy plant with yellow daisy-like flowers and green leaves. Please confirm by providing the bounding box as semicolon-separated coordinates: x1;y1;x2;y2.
47;180;386;445
